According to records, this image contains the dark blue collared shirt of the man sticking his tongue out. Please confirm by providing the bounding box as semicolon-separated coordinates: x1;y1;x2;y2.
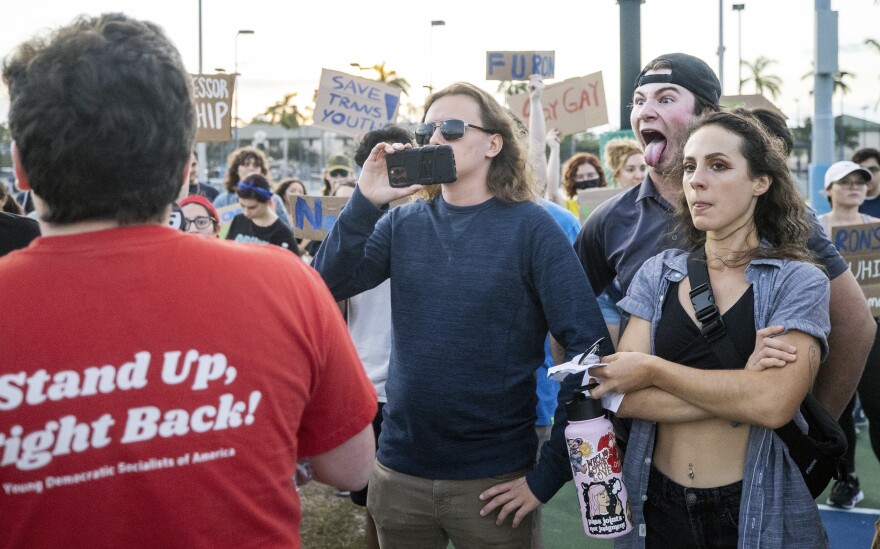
574;174;849;295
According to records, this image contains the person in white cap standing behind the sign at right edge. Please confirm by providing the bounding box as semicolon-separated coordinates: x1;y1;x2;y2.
819;160;880;509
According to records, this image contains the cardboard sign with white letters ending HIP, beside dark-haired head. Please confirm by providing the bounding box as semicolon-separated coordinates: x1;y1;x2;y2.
190;74;235;142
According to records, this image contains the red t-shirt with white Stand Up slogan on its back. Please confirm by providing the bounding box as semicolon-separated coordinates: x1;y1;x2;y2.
0;226;376;548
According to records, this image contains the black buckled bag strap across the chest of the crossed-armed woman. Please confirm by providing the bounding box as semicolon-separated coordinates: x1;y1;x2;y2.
688;249;743;370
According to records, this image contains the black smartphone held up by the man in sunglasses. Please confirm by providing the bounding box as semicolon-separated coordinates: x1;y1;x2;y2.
385;145;456;187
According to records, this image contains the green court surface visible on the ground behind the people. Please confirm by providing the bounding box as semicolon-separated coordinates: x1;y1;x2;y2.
542;427;880;549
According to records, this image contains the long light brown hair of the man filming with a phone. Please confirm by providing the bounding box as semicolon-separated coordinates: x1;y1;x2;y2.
419;82;538;202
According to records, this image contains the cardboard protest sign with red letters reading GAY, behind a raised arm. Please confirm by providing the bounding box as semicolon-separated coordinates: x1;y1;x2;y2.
507;72;608;136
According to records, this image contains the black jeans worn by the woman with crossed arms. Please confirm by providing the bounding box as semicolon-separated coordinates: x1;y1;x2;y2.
645;467;742;549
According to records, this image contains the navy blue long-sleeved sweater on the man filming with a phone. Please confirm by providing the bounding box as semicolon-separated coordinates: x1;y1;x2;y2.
313;190;611;501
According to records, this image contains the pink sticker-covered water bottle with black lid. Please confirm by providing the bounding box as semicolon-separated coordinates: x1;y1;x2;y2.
565;391;632;539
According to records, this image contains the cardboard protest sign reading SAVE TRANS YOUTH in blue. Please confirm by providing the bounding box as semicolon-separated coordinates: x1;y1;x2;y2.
313;69;400;137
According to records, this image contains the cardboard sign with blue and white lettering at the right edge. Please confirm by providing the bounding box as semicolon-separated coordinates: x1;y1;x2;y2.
831;223;880;316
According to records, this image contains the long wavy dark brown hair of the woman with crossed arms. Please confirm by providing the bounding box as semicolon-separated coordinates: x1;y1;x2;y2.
670;112;815;264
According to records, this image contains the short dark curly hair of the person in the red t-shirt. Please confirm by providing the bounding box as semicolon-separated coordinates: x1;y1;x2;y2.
3;14;196;225
